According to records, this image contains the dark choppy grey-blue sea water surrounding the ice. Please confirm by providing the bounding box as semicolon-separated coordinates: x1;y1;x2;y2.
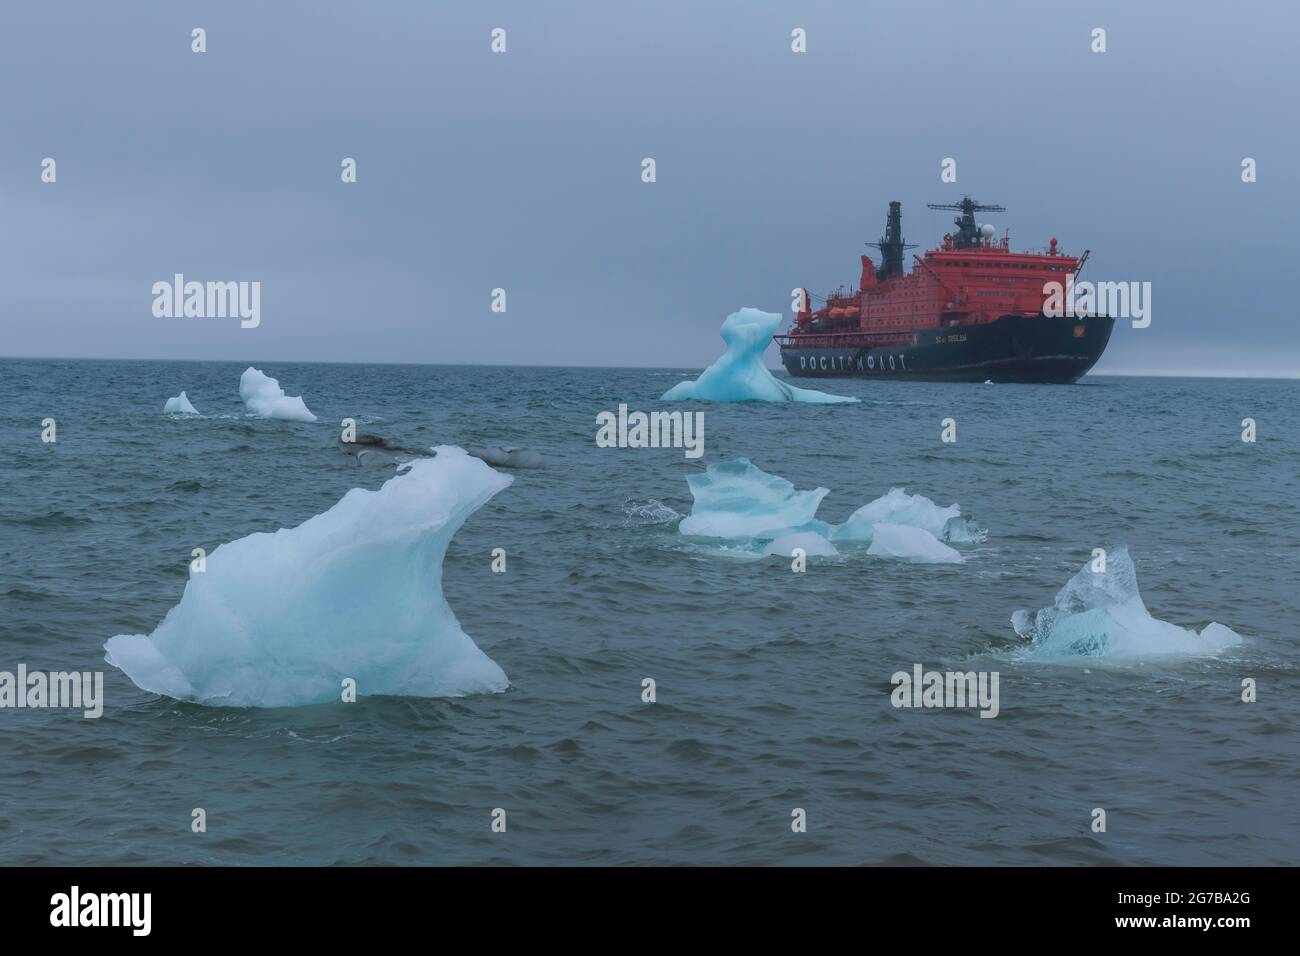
0;362;1300;865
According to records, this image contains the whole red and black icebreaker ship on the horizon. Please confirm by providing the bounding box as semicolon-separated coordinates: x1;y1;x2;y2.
776;196;1114;382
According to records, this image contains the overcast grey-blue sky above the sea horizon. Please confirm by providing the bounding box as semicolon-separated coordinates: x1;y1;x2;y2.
0;0;1300;375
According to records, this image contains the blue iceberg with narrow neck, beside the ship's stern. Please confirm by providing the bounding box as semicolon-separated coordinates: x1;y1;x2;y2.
663;308;858;405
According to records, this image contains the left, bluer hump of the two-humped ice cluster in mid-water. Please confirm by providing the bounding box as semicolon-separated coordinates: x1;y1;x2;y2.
677;458;829;540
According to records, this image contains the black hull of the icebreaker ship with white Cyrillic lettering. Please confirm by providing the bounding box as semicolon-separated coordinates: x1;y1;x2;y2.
781;315;1115;384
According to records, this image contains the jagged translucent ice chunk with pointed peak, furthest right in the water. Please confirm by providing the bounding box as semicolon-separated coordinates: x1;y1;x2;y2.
1011;548;1242;661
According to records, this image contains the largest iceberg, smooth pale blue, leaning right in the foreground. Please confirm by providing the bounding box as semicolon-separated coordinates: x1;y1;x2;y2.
104;445;512;708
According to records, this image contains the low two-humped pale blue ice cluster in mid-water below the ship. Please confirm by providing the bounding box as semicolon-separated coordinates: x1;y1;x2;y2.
677;458;987;563
